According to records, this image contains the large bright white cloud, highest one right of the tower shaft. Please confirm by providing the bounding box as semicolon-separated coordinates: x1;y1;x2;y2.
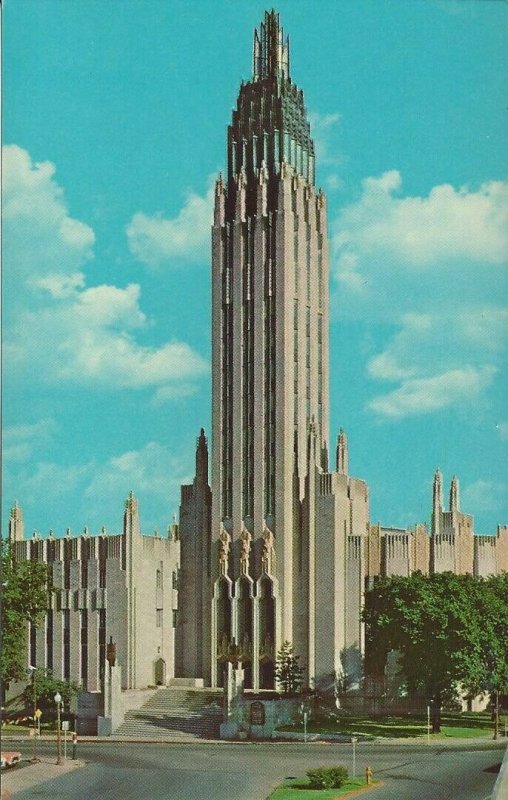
332;170;508;274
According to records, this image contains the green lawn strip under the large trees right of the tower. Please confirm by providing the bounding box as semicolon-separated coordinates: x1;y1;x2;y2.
279;712;498;739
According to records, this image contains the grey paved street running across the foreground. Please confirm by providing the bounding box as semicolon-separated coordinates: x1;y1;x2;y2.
3;742;504;800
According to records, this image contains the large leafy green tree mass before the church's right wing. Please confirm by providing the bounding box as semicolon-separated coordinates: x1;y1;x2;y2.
363;572;508;732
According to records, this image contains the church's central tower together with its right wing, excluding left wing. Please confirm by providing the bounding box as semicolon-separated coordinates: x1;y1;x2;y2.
177;11;508;690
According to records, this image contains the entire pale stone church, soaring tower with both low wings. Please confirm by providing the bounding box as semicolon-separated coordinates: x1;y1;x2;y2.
9;11;508;691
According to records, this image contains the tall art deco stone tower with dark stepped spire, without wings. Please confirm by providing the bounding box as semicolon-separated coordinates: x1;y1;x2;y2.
210;11;329;687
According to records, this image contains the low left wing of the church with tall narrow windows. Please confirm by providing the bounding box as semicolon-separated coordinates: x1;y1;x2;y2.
9;494;180;692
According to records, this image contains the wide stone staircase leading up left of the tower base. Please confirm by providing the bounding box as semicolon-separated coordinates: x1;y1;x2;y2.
113;687;223;741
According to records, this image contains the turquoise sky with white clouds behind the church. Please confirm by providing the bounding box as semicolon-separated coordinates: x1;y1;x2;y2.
3;0;508;535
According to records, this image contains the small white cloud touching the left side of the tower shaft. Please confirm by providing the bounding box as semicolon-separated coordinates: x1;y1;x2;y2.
126;182;214;267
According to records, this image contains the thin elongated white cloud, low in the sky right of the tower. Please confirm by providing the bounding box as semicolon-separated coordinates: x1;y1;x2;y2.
368;367;496;418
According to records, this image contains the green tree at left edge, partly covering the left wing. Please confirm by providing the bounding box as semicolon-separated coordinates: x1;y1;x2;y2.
0;540;50;687
